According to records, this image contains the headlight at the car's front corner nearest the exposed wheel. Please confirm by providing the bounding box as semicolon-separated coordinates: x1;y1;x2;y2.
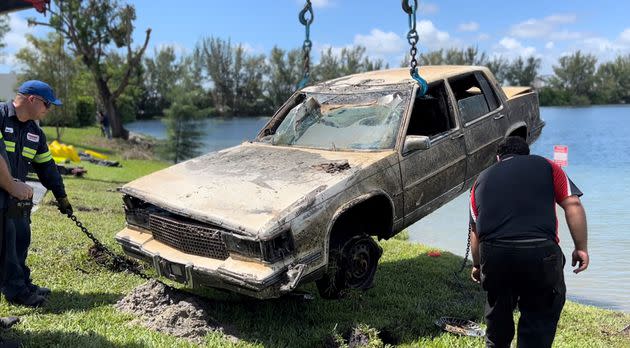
222;230;294;262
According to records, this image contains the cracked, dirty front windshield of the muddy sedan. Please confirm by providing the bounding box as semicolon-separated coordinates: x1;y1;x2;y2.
262;91;410;150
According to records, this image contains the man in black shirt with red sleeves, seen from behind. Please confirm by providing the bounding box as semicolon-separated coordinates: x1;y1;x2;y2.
470;137;589;347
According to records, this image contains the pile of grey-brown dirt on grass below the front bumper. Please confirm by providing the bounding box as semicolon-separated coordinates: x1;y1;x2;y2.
116;280;238;343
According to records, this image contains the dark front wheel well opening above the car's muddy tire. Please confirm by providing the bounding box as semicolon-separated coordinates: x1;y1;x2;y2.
331;195;393;242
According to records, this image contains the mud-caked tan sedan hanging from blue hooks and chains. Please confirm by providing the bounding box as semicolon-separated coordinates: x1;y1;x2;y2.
116;66;544;299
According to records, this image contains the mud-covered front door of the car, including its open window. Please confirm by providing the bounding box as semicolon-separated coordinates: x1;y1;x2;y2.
400;81;466;225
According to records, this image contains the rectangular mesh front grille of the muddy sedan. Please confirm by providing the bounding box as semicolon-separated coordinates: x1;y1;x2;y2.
149;214;229;260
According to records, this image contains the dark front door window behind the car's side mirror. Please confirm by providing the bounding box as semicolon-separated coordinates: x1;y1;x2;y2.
406;81;456;138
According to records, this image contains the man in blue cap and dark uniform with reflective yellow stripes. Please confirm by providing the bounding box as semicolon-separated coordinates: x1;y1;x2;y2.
0;80;72;307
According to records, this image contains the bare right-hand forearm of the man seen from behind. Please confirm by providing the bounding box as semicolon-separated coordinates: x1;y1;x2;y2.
558;196;589;273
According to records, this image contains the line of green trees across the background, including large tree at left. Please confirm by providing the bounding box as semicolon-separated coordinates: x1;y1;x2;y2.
0;0;630;161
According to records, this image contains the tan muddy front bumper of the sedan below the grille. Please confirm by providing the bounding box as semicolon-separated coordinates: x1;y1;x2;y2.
116;227;308;299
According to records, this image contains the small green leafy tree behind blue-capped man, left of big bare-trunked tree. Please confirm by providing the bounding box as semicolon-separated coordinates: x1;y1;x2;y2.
16;32;84;140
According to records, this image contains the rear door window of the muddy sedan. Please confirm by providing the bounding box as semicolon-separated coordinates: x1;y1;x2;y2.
449;73;499;123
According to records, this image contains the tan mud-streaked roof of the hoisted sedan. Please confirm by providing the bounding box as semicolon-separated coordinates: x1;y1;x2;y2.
304;65;489;92
